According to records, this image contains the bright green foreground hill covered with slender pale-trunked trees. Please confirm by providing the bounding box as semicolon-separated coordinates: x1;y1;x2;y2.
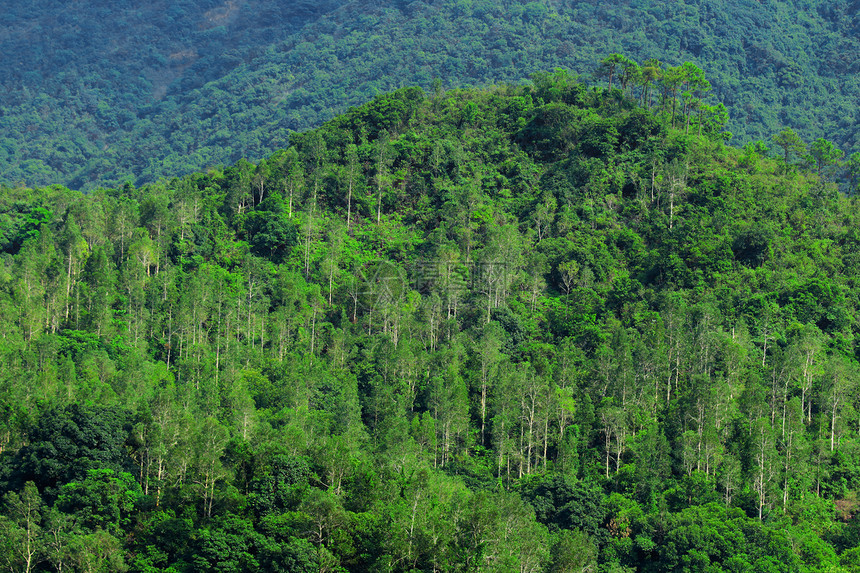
0;75;860;573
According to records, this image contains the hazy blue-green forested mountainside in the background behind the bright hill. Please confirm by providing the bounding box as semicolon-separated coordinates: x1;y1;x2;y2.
0;0;860;189
